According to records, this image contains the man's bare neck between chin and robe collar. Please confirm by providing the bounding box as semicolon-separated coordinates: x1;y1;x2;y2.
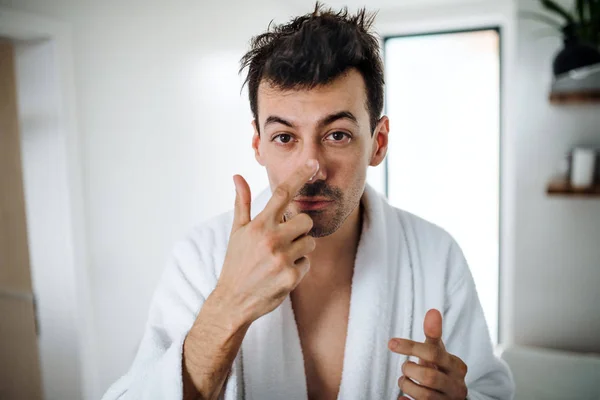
303;197;363;284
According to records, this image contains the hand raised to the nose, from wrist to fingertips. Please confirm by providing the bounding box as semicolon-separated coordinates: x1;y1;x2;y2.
215;160;318;323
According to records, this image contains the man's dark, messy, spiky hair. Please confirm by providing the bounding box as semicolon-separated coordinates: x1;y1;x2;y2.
240;2;384;135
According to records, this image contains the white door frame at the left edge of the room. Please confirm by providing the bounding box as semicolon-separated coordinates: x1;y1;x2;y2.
0;7;98;399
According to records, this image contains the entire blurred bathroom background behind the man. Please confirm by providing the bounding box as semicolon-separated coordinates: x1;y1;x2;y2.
0;0;600;399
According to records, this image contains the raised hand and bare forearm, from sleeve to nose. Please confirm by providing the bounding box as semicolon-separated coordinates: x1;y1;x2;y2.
182;160;318;400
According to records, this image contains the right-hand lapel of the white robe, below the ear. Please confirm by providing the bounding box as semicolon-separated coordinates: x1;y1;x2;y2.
338;186;413;400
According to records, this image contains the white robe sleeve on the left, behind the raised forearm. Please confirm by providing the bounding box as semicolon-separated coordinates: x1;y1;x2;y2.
103;242;205;400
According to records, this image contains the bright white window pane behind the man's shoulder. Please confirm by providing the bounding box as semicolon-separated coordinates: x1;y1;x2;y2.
384;29;500;343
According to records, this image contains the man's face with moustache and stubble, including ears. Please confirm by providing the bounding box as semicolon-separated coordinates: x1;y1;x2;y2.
252;69;389;237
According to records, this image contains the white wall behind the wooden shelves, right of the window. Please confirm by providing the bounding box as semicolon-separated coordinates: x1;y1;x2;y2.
507;1;600;352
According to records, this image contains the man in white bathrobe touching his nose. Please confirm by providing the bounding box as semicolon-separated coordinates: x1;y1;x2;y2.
105;5;513;400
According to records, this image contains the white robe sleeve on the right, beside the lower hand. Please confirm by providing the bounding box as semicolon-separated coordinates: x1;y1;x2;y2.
443;243;514;400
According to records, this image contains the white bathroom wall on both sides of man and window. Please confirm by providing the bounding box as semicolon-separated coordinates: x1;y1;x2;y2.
0;0;600;398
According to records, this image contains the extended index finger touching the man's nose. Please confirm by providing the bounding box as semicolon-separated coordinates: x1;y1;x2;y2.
261;159;319;222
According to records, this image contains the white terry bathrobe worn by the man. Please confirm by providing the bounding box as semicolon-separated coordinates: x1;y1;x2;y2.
104;186;513;400
